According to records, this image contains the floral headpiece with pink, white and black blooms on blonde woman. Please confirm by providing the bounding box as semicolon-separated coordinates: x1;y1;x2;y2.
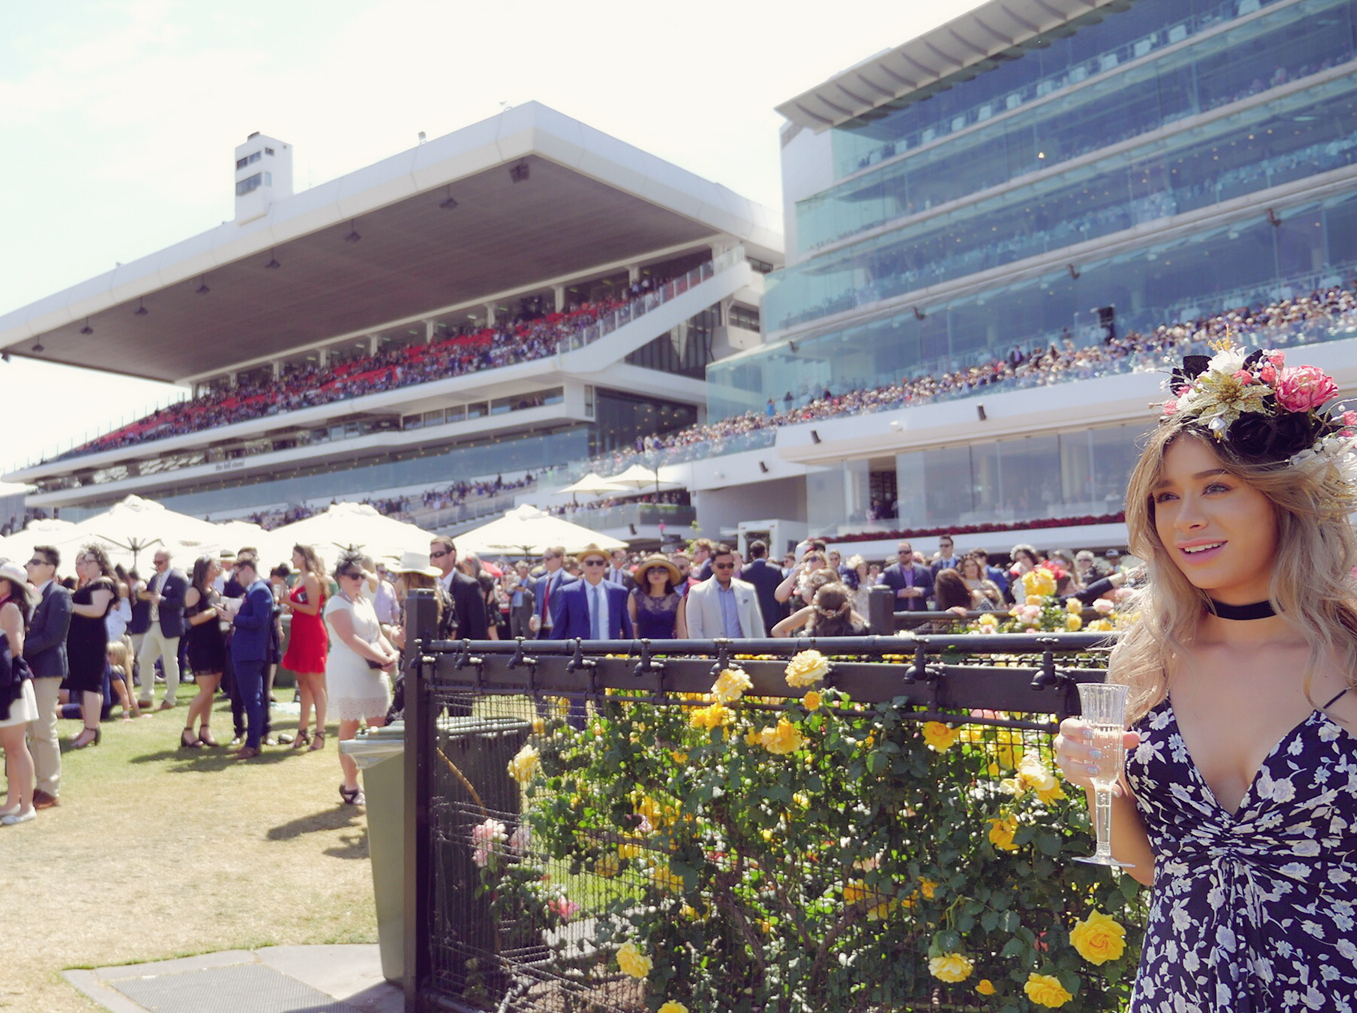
1160;338;1357;513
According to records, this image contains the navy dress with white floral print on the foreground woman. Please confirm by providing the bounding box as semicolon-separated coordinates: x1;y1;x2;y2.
1126;694;1357;1013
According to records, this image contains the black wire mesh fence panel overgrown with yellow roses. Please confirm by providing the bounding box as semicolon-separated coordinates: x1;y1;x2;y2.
407;602;1143;1013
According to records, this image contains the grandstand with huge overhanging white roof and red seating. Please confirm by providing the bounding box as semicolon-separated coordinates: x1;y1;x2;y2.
0;103;782;545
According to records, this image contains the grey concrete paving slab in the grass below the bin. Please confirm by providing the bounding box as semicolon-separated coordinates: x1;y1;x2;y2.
65;945;404;1013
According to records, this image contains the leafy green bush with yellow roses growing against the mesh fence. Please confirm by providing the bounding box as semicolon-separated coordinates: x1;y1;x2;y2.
510;651;1143;1013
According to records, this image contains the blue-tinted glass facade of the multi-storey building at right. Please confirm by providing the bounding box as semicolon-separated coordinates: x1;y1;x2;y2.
727;0;1357;418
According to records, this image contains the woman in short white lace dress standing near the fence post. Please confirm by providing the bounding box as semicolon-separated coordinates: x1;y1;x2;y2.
326;553;400;805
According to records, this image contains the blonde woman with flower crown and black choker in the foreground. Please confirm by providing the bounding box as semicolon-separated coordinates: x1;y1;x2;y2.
1056;342;1357;1013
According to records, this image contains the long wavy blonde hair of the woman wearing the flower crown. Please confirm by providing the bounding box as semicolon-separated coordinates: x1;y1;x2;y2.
1109;424;1357;724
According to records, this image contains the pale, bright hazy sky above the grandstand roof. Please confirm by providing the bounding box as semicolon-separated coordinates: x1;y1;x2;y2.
0;0;977;467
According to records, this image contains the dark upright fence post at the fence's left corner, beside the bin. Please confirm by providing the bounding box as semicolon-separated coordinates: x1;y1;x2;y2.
402;591;438;1013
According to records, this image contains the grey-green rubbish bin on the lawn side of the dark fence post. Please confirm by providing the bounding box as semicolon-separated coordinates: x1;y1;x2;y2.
339;721;406;984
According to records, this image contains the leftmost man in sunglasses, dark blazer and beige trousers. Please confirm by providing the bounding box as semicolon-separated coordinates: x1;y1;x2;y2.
23;545;71;809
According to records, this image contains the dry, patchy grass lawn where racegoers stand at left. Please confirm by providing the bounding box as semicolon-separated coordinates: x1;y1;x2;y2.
0;686;377;1013
